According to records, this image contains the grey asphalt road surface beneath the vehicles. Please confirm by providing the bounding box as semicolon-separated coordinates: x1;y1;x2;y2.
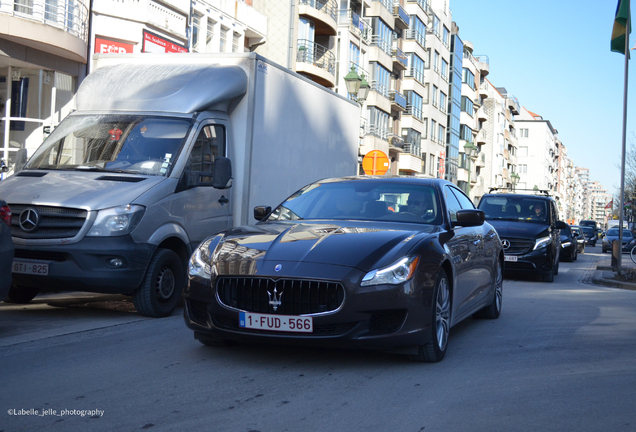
0;246;636;432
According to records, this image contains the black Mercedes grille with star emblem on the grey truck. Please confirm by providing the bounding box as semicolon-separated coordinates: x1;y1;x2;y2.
9;204;88;239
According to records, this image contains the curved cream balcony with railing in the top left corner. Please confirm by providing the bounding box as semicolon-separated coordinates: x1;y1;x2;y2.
0;0;89;63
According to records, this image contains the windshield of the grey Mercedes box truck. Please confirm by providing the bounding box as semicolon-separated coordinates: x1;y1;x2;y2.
25;114;192;176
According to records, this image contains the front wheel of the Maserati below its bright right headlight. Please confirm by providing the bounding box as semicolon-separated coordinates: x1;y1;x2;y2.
409;269;451;363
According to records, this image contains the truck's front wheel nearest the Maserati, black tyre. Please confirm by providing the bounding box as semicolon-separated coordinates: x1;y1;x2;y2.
133;249;185;318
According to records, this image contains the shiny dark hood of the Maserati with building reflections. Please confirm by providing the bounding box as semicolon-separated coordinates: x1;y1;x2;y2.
211;221;440;274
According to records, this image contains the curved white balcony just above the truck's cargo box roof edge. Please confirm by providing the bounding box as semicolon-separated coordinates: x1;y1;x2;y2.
296;39;336;88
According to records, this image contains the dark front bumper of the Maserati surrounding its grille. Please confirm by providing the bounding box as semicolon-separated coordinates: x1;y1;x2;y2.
184;264;437;350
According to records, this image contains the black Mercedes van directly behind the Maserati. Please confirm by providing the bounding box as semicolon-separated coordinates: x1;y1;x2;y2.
479;189;567;282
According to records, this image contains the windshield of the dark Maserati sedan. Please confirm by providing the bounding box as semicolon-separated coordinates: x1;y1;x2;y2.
267;179;443;225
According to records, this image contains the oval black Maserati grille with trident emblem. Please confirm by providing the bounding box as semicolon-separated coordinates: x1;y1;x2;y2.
216;277;344;315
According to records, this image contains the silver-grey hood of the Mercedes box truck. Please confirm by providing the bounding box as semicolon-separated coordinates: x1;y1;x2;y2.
0;171;166;210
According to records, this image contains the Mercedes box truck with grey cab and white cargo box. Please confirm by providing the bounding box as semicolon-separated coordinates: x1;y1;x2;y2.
0;53;360;316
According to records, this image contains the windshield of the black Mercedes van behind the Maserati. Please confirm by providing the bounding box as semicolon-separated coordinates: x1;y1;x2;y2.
479;196;548;223
